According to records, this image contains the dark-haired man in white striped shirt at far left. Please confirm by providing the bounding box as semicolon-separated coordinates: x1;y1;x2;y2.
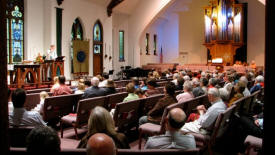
9;88;46;126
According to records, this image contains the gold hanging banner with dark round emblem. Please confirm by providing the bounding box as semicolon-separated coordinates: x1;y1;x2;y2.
73;40;90;73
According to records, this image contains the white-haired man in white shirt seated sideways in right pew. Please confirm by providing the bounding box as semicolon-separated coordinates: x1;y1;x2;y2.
181;88;227;134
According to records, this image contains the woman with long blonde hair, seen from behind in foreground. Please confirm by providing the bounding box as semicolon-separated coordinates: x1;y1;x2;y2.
78;106;130;149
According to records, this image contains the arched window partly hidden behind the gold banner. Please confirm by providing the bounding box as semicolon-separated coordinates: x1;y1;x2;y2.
71;18;84;73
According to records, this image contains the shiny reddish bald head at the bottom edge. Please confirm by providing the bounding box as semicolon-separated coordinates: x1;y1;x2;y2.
87;133;116;155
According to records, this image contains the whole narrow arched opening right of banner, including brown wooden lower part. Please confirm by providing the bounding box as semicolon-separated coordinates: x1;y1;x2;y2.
93;20;103;75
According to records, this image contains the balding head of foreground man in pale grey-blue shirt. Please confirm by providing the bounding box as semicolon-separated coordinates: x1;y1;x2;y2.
167;108;186;130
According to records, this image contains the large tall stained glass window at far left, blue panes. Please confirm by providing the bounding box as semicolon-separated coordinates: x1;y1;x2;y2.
6;0;24;64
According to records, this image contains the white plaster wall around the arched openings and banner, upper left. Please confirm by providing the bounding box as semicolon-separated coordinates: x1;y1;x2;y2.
25;0;113;79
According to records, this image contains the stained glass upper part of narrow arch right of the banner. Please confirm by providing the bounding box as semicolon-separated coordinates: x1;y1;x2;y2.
93;20;103;54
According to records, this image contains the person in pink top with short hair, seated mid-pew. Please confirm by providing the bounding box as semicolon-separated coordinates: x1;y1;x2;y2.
176;81;194;103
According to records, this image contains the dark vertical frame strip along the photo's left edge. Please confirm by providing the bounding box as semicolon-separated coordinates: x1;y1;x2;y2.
0;0;9;155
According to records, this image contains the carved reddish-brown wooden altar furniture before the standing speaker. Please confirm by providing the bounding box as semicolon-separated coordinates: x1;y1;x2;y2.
8;59;64;88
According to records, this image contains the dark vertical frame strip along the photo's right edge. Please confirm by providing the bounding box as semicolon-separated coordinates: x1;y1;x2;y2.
262;0;275;154
